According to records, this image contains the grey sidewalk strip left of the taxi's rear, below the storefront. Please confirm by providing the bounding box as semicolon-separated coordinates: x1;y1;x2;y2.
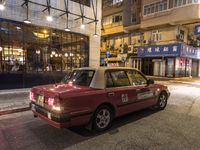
0;89;30;116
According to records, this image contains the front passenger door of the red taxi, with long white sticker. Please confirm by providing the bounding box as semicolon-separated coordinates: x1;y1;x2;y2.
127;70;156;110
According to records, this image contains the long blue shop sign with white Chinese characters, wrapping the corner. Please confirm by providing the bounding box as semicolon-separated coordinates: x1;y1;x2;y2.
138;43;200;59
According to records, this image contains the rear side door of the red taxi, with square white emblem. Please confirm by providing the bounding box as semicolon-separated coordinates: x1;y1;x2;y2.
105;70;137;116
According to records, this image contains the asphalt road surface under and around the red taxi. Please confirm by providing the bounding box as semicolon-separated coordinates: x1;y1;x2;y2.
0;82;200;150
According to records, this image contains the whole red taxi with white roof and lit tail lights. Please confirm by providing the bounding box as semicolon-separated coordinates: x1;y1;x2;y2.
30;67;170;131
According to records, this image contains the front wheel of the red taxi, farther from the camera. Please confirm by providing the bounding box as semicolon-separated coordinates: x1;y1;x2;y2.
155;92;168;110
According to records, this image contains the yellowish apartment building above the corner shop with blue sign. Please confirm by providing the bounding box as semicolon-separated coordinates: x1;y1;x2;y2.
101;0;200;77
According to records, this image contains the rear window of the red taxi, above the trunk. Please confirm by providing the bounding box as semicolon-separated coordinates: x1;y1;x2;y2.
63;70;95;86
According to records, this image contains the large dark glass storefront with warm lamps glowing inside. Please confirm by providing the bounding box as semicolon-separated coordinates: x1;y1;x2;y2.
0;19;89;73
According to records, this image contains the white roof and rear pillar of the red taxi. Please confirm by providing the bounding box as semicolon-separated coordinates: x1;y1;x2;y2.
74;67;137;89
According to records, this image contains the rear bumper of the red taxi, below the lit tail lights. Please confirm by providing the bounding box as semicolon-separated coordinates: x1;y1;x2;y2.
30;102;70;128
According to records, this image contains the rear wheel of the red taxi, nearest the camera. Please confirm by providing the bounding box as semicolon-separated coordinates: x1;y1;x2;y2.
93;105;114;132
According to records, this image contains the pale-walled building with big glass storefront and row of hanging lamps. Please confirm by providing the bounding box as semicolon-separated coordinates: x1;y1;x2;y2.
0;0;102;89
